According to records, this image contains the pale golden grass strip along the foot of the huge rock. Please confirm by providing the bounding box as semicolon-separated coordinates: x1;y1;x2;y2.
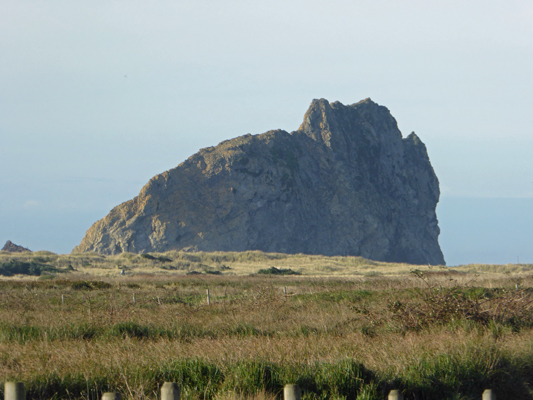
0;251;533;281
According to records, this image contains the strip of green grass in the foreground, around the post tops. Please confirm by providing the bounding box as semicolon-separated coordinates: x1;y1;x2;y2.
0;349;531;400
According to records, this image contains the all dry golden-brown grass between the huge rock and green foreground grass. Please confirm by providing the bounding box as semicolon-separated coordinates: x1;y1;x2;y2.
0;252;533;400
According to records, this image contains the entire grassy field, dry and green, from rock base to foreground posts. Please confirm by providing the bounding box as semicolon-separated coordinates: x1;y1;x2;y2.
0;252;533;400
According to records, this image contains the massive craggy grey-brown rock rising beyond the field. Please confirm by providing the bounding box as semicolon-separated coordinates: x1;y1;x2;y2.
73;99;444;264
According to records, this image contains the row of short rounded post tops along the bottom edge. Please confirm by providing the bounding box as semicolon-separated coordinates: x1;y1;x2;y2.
4;382;496;400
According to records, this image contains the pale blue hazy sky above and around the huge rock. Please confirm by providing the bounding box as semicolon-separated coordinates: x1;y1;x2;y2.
0;0;533;265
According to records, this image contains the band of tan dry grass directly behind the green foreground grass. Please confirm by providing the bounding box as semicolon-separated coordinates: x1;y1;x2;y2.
4;329;533;380
